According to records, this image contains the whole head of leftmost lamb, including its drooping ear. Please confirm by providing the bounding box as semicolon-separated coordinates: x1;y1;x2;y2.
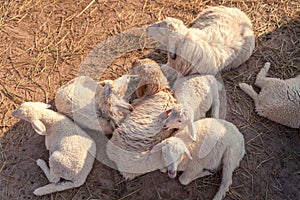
12;102;51;135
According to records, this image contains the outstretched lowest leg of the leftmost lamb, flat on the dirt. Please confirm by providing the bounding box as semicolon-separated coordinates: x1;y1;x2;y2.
33;181;80;196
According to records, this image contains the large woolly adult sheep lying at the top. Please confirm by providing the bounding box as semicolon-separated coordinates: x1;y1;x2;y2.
146;6;255;76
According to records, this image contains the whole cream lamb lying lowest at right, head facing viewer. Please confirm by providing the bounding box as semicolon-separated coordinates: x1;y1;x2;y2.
150;118;245;200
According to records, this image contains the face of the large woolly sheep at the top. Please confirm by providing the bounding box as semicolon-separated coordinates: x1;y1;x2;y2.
146;17;187;46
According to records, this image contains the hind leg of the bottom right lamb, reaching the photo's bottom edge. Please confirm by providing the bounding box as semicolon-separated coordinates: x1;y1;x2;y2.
213;150;236;200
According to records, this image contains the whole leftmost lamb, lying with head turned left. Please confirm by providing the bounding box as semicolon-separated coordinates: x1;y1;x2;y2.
12;102;96;195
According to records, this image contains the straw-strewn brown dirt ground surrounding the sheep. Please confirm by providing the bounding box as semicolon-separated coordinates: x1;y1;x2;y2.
0;0;300;200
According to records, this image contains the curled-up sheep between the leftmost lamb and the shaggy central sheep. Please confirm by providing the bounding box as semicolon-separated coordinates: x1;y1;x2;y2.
55;75;132;135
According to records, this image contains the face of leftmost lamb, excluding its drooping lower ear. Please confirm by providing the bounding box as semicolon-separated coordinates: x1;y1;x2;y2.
12;102;51;121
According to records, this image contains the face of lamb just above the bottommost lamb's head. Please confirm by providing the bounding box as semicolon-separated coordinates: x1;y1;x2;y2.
163;106;189;130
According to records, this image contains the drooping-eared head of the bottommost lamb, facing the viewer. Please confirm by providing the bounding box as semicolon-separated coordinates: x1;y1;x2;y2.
150;137;192;178
